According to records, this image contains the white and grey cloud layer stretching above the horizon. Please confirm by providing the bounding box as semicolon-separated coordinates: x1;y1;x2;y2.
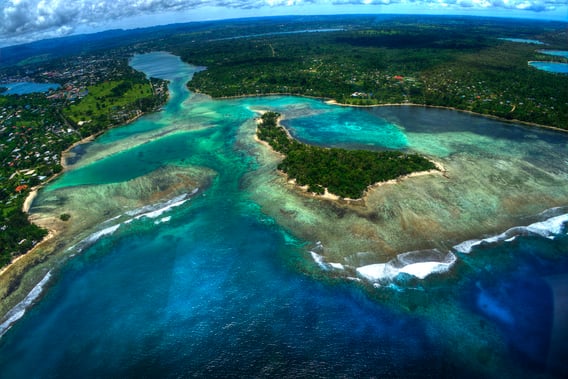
0;0;568;46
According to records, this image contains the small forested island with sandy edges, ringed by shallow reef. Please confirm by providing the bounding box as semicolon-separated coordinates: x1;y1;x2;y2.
257;112;437;199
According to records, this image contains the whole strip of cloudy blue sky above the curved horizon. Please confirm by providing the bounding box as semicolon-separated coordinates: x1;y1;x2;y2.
0;0;568;47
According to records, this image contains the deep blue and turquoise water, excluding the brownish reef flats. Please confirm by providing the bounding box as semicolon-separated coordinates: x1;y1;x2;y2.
0;53;568;378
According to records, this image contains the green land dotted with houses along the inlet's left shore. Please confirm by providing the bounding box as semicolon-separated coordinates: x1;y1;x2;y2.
0;54;167;267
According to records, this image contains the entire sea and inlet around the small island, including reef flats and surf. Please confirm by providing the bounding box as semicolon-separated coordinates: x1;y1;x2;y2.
0;53;568;377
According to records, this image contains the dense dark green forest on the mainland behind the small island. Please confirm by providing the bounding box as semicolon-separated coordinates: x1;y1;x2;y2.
154;16;568;128
